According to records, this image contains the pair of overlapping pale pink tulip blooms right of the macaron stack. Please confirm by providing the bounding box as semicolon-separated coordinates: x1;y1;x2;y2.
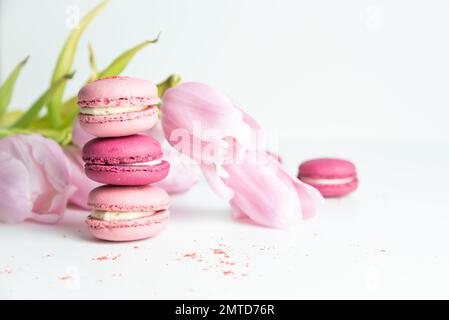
162;83;322;228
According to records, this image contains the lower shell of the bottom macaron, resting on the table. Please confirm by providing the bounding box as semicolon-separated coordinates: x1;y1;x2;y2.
86;210;170;241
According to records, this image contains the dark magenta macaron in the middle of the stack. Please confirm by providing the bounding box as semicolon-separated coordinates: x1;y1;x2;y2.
83;134;170;186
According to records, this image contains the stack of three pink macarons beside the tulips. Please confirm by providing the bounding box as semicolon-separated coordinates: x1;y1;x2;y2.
78;77;170;241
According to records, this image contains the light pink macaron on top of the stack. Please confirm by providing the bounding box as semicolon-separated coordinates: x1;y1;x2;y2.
78;76;160;137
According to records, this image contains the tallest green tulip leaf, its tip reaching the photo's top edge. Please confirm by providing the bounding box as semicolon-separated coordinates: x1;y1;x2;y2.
48;0;109;127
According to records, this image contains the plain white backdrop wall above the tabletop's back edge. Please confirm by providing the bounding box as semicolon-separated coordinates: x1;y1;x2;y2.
0;0;449;141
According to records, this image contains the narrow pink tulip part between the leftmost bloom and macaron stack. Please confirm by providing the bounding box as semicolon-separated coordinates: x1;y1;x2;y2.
64;146;100;210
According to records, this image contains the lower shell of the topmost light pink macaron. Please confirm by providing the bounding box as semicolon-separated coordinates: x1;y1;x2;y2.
79;107;159;137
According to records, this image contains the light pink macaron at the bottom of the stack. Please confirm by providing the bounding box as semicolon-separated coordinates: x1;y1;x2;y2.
86;186;169;241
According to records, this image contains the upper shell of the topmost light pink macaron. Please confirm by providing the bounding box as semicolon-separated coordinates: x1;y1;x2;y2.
78;76;160;107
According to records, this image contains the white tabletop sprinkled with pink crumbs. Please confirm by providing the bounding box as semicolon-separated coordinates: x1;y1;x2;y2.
0;143;449;299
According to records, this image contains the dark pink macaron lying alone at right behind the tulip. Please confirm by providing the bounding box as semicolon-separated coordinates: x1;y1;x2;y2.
298;158;359;197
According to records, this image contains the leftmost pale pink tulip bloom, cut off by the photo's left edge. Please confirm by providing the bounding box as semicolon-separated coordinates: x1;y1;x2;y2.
0;134;75;223
